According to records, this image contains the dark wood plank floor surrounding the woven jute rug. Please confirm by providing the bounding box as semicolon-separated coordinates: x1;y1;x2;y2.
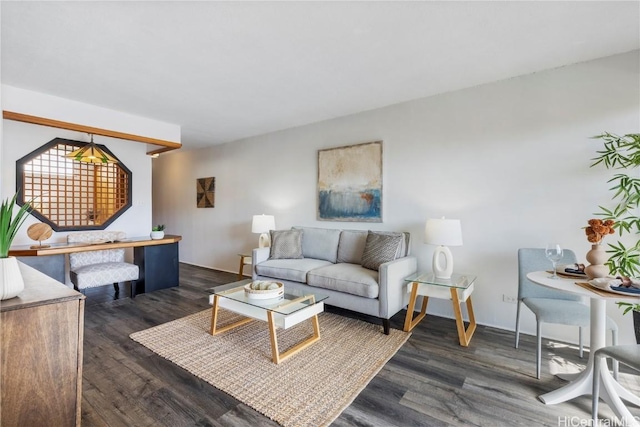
82;264;640;427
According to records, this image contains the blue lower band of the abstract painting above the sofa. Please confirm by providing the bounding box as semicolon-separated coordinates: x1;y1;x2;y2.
318;189;382;222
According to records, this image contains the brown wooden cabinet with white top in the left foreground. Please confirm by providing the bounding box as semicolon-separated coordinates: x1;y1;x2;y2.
0;264;84;427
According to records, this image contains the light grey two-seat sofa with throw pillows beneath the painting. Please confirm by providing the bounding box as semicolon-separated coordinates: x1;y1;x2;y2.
252;227;417;335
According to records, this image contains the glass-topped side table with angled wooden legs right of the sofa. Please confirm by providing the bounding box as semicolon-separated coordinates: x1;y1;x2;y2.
404;272;476;347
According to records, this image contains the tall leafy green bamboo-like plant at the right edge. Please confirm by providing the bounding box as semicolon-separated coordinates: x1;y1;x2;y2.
591;132;640;278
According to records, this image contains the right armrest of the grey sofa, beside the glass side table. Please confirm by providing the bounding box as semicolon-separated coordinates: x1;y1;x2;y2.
378;256;418;319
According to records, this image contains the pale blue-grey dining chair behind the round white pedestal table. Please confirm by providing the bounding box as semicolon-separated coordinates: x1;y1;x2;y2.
515;248;618;379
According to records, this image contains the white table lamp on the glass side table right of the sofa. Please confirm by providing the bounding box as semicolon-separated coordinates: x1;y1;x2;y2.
424;217;462;279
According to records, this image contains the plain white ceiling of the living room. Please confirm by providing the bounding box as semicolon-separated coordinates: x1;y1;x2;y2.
1;0;640;148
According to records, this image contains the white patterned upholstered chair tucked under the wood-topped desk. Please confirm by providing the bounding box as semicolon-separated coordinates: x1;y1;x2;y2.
67;231;140;298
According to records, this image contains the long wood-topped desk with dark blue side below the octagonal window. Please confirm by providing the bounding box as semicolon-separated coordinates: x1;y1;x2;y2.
9;235;182;294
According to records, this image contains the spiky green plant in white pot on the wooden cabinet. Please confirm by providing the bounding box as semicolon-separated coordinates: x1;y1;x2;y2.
0;193;31;300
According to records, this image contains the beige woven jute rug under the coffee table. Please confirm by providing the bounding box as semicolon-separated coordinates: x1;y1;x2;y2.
131;309;411;427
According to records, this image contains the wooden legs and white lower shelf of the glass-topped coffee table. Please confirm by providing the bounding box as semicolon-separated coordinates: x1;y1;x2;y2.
209;287;324;364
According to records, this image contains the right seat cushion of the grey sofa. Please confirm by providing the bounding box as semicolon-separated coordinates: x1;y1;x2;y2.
307;263;380;298
